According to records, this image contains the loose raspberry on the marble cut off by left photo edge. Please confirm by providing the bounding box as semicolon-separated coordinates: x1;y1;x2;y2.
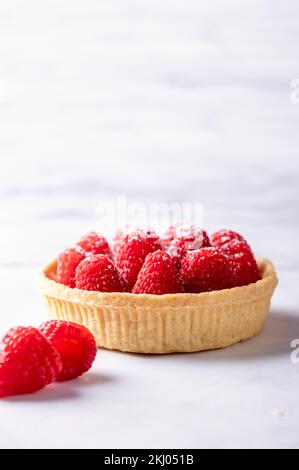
0;326;62;397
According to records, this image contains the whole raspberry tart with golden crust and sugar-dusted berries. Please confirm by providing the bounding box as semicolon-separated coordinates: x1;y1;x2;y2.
39;226;277;354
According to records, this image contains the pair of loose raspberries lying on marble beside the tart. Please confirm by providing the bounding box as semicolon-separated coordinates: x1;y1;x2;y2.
0;320;97;397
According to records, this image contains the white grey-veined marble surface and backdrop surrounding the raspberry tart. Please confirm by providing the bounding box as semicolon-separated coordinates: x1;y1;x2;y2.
0;0;299;448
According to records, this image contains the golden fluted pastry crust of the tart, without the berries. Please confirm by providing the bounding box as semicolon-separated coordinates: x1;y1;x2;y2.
38;258;277;354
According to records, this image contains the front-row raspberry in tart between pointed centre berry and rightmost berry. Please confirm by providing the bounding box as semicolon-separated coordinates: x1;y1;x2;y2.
180;247;232;293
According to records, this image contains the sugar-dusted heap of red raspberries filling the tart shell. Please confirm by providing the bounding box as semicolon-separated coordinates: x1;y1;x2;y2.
57;225;260;295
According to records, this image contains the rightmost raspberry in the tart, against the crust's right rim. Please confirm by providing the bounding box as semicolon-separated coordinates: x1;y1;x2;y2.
222;240;261;287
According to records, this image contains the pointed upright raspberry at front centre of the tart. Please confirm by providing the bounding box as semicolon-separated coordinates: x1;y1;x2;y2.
133;250;182;295
